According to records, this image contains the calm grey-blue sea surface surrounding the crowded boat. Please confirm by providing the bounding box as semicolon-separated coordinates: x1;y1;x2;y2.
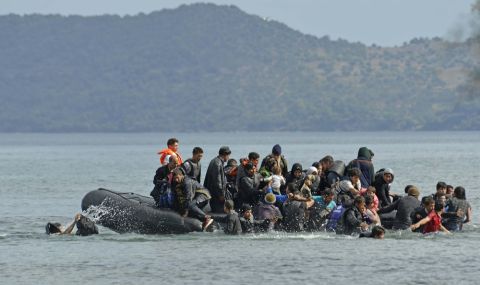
0;132;480;284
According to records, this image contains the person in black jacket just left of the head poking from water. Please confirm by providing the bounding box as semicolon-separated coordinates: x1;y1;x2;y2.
336;196;368;235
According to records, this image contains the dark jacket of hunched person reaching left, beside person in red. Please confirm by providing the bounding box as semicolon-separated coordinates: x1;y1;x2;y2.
378;196;420;230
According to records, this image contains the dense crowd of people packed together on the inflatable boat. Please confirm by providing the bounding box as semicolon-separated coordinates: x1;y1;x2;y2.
151;138;472;239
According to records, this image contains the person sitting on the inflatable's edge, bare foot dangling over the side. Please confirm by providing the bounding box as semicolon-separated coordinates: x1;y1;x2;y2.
172;168;213;229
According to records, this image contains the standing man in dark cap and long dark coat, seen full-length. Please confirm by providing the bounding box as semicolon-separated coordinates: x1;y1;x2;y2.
203;146;232;213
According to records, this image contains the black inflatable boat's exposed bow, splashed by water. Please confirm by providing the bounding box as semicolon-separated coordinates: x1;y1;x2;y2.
82;188;202;234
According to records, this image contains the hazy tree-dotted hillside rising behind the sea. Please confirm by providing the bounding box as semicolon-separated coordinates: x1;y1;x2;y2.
0;4;480;132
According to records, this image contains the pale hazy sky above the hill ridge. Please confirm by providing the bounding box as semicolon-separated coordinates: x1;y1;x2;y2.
0;0;475;46
